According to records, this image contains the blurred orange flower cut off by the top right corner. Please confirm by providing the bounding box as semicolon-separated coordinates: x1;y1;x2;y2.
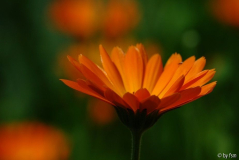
211;0;239;27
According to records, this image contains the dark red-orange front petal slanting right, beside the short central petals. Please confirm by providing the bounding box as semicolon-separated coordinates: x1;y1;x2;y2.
157;93;181;110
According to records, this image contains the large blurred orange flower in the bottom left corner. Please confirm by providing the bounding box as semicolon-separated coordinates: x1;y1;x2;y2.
0;122;69;160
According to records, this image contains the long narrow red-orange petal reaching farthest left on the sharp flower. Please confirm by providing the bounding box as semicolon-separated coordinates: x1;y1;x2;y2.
60;79;113;105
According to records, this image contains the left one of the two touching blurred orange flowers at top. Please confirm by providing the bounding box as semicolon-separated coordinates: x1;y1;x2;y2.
49;0;100;38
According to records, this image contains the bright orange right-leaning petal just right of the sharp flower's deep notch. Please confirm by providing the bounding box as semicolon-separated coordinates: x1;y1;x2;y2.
152;53;182;95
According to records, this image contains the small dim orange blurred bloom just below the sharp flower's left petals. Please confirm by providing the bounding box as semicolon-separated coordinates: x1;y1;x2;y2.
88;99;115;126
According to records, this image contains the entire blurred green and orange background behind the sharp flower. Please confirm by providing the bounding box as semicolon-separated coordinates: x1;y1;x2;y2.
0;0;239;160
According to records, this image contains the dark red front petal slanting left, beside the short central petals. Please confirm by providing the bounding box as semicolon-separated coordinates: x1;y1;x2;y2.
104;89;131;109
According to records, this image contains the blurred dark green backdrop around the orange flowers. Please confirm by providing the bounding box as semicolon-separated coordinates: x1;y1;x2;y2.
0;0;239;160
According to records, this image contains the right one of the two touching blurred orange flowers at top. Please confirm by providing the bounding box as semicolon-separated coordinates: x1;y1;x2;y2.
103;0;140;38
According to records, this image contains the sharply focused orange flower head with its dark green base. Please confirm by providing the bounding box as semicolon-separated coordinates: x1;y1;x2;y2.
62;44;216;130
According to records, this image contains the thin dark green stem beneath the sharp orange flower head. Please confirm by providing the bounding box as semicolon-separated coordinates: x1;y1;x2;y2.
131;131;142;160
